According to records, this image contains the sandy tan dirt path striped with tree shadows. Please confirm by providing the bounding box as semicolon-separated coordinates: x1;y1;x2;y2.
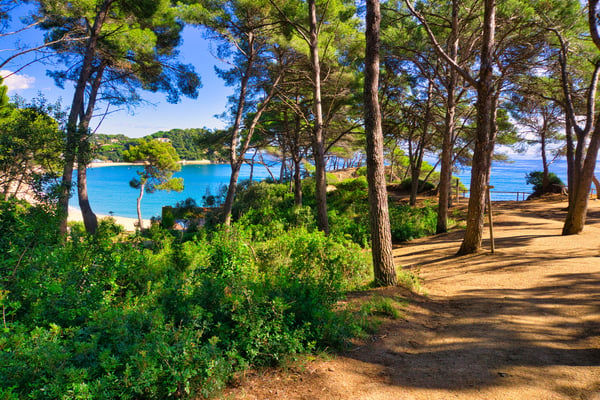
228;201;600;400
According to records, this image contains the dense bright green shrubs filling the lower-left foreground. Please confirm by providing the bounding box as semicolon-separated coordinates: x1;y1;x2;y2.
0;199;370;399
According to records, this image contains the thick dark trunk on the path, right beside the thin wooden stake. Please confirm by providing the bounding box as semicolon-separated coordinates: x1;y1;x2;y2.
457;0;496;255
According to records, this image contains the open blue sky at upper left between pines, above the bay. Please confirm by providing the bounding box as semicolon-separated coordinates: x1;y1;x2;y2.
0;5;233;137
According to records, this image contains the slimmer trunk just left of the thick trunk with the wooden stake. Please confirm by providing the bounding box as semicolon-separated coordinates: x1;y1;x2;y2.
436;0;459;234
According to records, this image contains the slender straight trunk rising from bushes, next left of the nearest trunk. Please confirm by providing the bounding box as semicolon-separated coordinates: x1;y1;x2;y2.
308;0;329;235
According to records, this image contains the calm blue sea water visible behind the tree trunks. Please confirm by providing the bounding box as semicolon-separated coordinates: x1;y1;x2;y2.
71;159;599;218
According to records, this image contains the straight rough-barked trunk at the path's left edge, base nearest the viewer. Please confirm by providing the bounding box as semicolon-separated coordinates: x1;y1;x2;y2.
364;0;397;286
